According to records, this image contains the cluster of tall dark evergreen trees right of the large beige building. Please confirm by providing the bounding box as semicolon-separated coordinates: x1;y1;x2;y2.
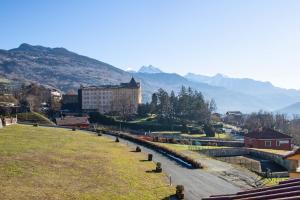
138;86;217;125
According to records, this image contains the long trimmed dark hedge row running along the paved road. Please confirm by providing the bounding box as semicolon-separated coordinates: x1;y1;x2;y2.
99;131;202;169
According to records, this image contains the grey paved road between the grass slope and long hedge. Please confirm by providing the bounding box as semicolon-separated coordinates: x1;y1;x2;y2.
105;135;241;200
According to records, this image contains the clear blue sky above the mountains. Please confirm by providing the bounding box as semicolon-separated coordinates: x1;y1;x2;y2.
0;0;300;89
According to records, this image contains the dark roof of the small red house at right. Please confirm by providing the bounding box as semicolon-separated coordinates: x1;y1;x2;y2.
245;128;292;139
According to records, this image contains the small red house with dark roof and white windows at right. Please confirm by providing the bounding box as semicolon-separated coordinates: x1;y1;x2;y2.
244;128;292;150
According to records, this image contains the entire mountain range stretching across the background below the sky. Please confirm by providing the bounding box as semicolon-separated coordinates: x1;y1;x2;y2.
0;44;300;115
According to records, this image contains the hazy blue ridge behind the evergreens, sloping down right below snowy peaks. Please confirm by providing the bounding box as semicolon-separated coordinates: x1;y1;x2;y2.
133;73;272;112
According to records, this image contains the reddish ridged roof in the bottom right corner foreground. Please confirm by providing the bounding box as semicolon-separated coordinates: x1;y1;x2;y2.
202;178;300;200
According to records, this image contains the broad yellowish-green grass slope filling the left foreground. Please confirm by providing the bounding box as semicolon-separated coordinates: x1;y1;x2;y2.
0;125;175;200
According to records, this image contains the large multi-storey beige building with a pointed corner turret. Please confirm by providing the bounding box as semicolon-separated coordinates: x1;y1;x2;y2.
78;78;142;114
